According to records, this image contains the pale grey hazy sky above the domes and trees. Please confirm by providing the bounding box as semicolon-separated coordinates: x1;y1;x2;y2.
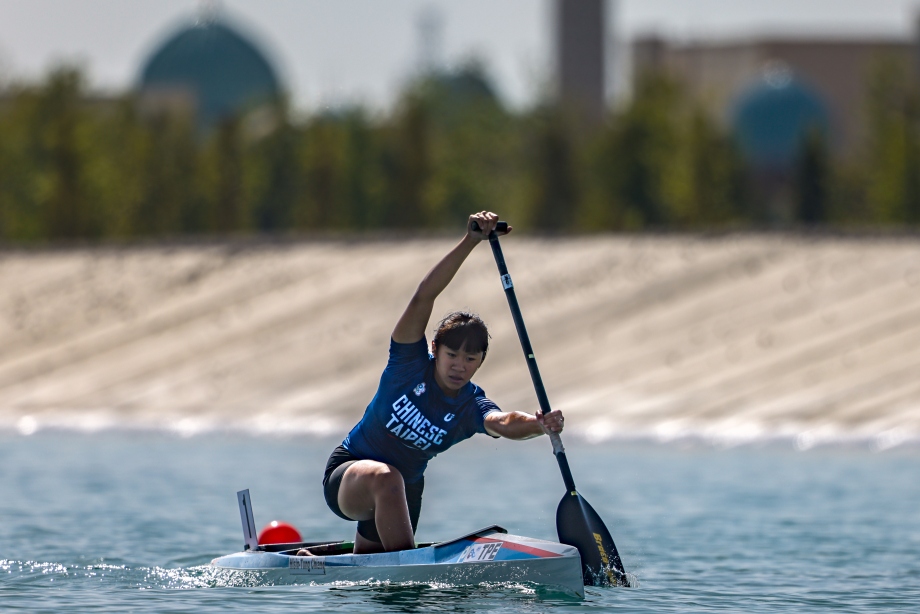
0;0;920;110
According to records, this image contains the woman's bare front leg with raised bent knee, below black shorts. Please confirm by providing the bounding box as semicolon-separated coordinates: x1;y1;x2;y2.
338;460;415;554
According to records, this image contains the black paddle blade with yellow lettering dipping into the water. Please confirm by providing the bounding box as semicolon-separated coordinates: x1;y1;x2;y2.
556;491;629;586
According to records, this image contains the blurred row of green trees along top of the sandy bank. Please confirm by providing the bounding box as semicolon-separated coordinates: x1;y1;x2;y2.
0;64;920;243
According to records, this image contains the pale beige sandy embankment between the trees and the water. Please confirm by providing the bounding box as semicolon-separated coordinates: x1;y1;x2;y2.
0;236;920;448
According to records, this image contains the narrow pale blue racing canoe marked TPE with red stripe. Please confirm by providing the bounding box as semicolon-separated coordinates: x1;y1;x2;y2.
211;525;585;598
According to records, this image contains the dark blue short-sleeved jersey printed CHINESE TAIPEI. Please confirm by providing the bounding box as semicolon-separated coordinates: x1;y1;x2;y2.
342;338;500;484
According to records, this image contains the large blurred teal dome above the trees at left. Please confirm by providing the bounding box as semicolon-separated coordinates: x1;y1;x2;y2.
140;21;281;126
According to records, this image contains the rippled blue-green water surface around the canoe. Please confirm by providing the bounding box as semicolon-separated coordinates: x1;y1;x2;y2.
0;431;920;613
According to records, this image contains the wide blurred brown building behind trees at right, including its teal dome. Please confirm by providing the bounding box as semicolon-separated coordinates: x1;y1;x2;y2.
633;36;920;163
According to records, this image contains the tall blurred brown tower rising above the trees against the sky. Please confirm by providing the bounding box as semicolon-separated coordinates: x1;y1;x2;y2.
555;0;607;127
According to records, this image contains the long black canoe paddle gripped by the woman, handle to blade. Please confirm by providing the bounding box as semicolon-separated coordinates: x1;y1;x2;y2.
473;222;629;586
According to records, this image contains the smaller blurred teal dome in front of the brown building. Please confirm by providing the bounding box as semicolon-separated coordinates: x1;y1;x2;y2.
732;72;830;169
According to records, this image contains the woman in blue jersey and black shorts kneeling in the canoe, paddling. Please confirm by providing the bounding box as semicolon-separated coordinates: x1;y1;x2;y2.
316;211;563;554
